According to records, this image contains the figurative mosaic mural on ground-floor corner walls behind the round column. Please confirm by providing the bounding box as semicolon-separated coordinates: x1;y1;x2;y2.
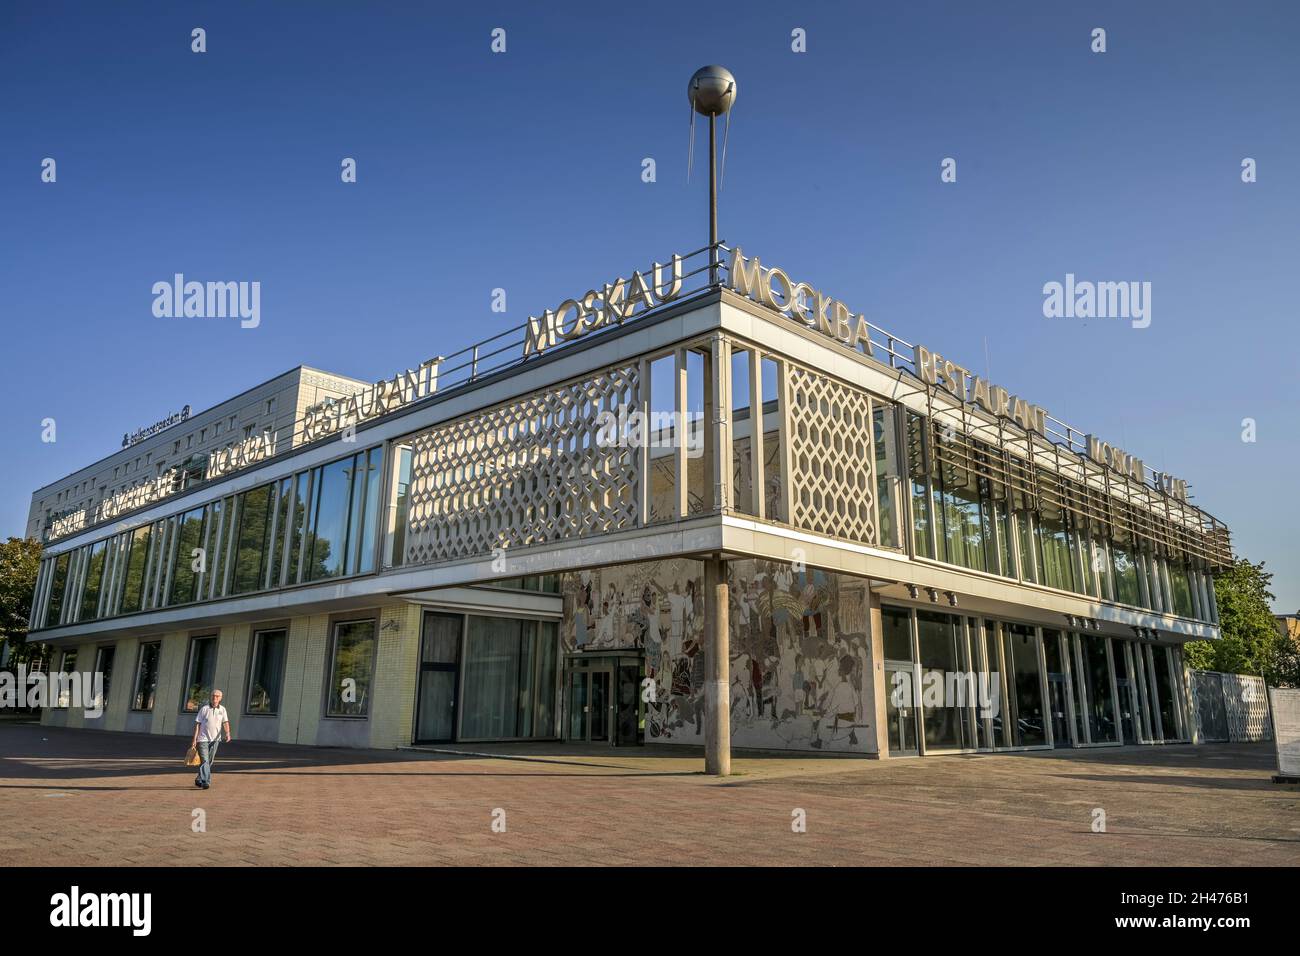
563;558;875;752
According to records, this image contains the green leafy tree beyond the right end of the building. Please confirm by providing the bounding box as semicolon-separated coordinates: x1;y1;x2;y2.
1184;558;1297;687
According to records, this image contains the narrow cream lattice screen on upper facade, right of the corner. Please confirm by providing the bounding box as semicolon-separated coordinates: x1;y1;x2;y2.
787;364;878;545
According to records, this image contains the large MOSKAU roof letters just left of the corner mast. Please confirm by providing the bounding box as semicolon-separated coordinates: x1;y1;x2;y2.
524;254;681;358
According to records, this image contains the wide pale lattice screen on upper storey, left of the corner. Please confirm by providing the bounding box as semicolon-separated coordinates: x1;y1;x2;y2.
406;365;640;564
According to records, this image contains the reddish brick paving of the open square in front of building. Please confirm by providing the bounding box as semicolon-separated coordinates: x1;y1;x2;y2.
0;722;1300;866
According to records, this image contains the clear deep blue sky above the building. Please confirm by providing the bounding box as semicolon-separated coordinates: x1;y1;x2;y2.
0;0;1300;611
